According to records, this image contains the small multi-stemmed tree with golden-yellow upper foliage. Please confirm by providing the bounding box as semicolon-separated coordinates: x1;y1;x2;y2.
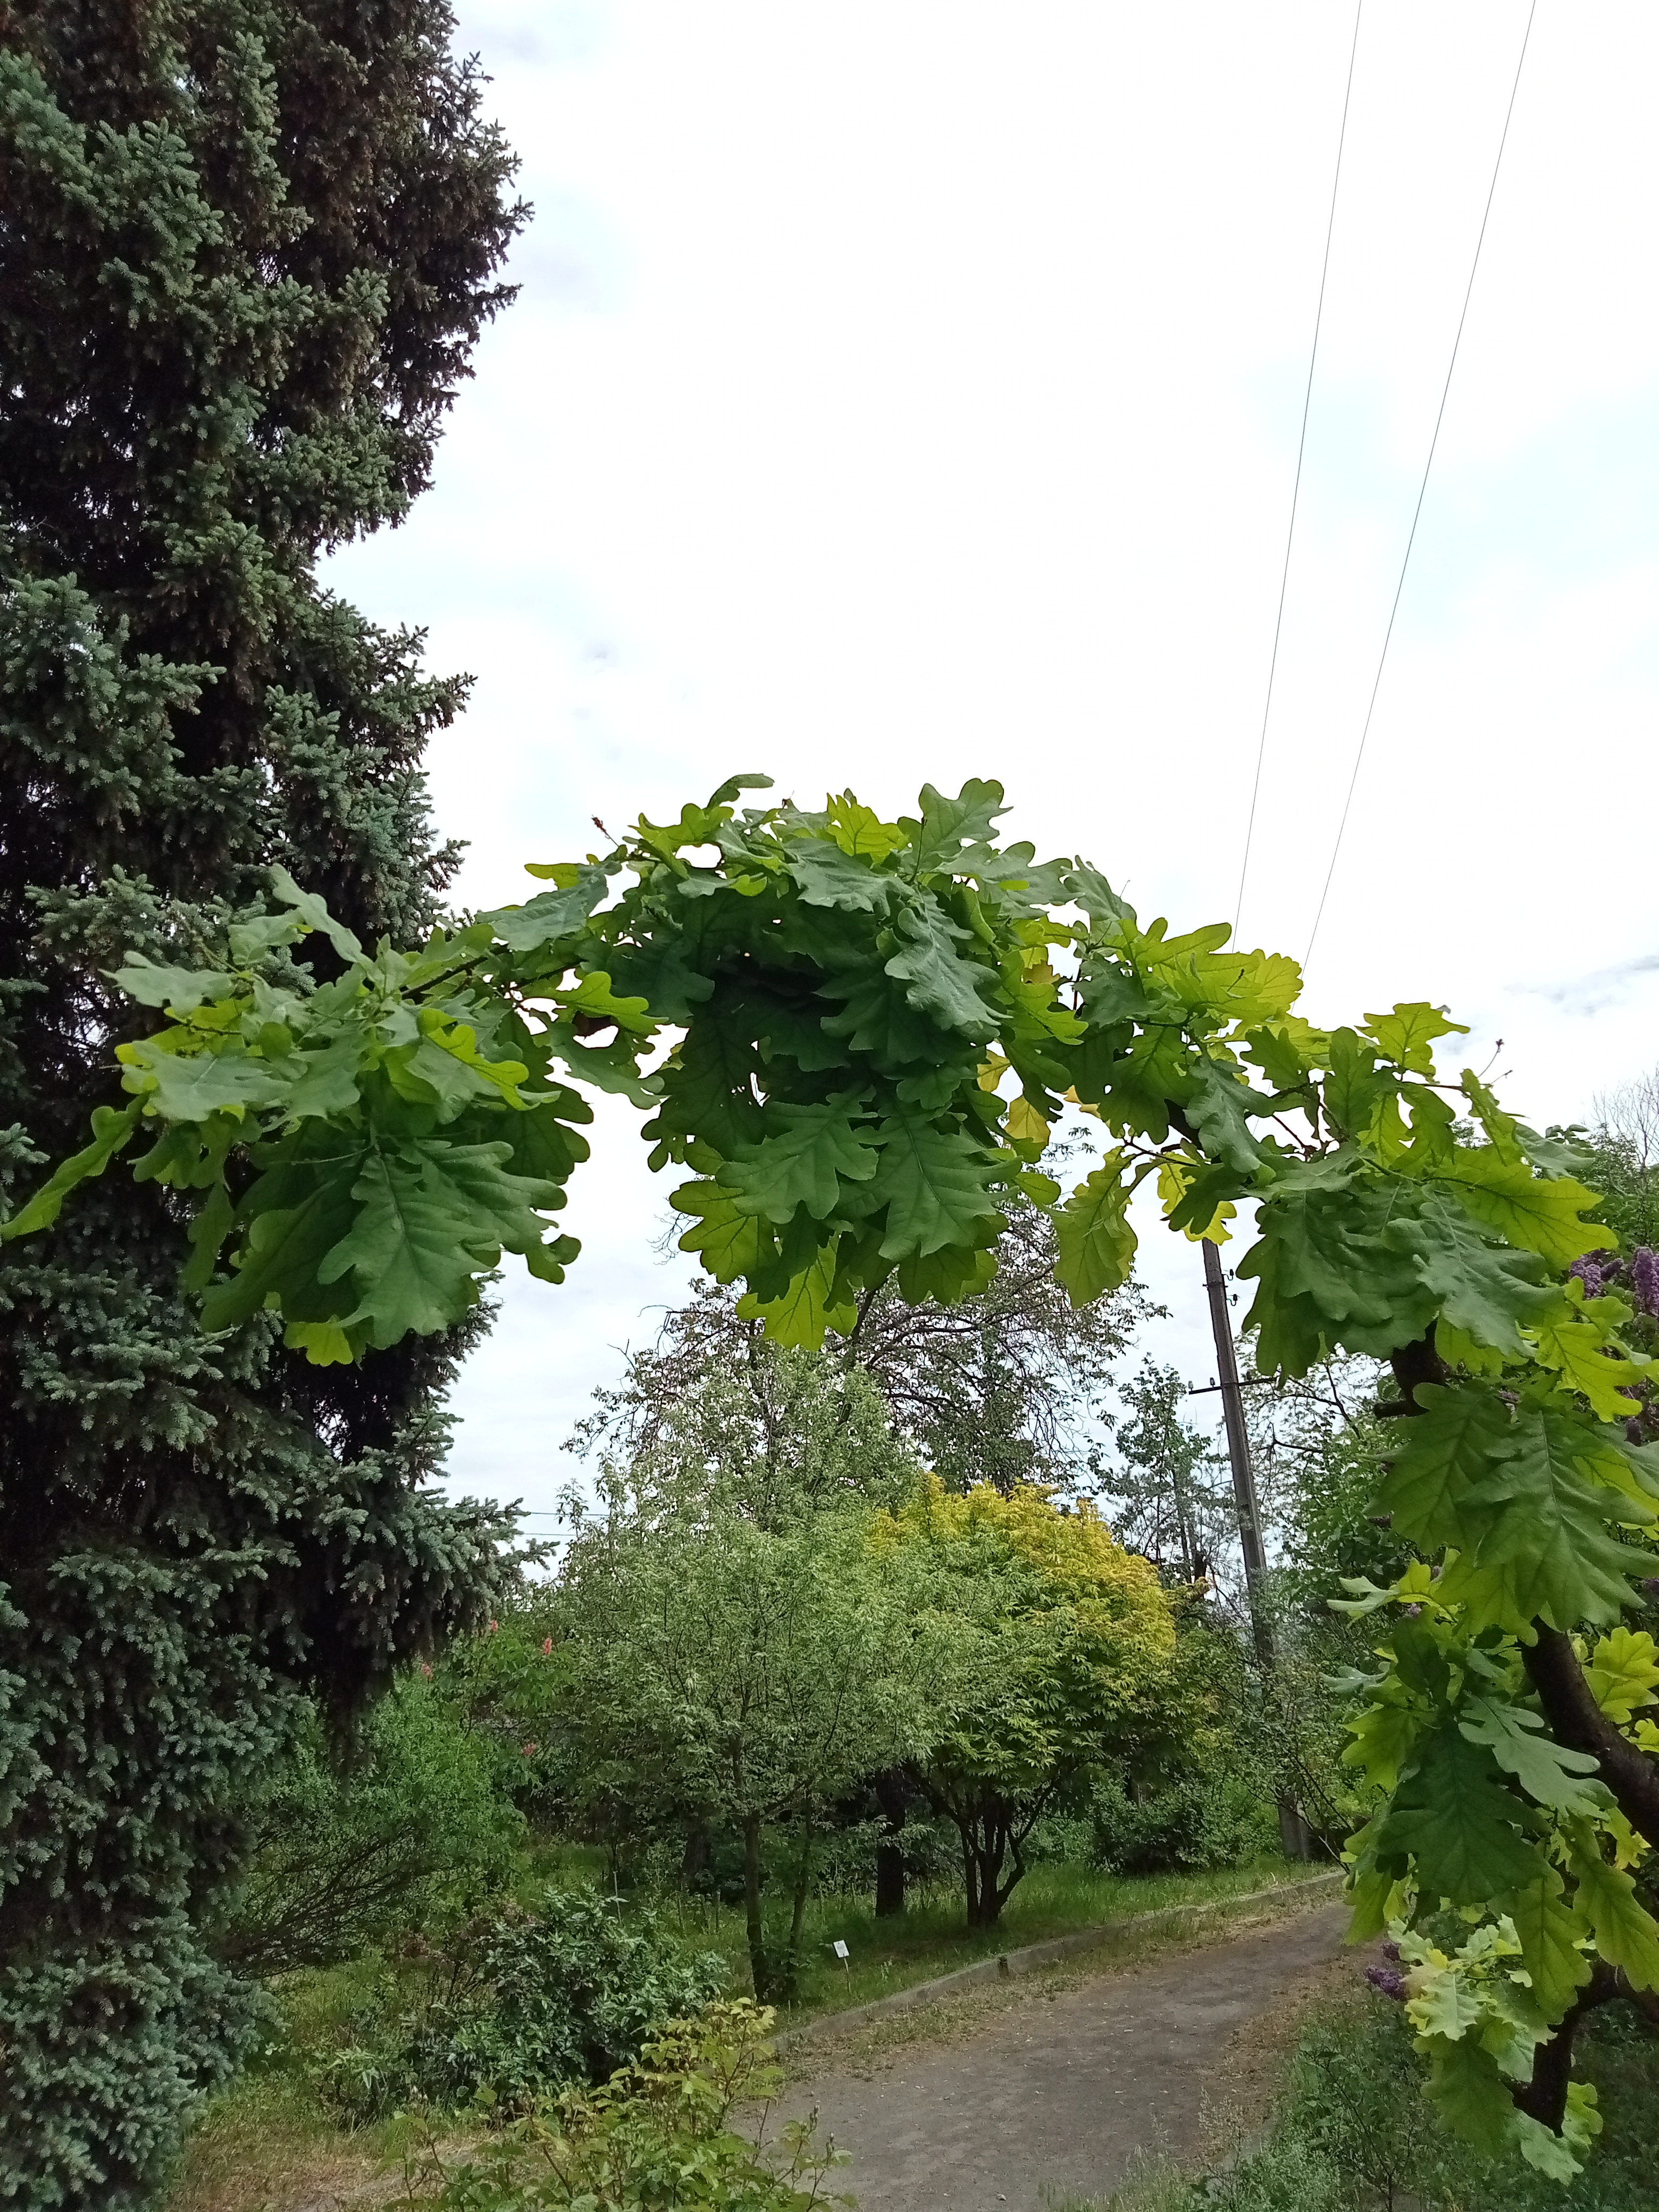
883;1480;1175;1926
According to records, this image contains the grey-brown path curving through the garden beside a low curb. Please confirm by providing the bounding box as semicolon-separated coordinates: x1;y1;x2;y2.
783;1905;1363;2212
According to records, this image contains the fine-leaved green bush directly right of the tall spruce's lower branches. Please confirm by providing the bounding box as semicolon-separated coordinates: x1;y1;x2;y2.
217;1677;524;1973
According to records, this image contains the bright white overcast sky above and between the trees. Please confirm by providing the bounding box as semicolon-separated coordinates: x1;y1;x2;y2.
321;0;1659;1509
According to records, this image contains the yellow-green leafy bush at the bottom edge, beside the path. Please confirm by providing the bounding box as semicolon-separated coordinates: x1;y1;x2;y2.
396;1997;852;2212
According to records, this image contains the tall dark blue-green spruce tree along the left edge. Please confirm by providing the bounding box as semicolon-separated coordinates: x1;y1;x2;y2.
0;0;524;2208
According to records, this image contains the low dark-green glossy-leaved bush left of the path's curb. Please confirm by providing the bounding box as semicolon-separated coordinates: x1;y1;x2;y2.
323;1891;725;2121
